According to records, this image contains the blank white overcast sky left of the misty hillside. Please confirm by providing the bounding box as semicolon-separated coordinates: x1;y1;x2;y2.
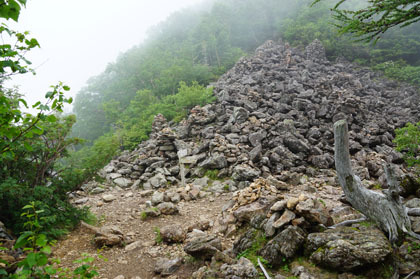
9;0;200;112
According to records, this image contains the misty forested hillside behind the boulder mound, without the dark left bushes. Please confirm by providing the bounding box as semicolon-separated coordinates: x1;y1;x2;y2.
73;0;420;159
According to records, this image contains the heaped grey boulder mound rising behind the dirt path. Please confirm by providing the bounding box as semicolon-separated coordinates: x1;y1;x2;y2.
102;40;420;191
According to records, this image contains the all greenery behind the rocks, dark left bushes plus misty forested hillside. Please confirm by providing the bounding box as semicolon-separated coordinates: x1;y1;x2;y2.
0;0;420;241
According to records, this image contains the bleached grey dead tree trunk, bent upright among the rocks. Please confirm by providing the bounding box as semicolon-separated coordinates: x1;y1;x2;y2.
334;120;420;243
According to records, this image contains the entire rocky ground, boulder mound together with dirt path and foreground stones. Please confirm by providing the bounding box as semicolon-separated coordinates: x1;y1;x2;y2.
57;41;420;279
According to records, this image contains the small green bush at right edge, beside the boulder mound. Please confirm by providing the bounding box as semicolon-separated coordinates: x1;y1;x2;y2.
394;122;420;167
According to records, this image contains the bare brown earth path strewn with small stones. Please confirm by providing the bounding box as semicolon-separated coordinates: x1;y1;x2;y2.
54;190;231;279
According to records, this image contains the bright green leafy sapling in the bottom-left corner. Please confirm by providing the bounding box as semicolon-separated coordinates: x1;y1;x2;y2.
0;202;99;279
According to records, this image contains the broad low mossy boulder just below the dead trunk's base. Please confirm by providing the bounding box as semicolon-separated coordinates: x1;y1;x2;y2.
306;226;392;271
